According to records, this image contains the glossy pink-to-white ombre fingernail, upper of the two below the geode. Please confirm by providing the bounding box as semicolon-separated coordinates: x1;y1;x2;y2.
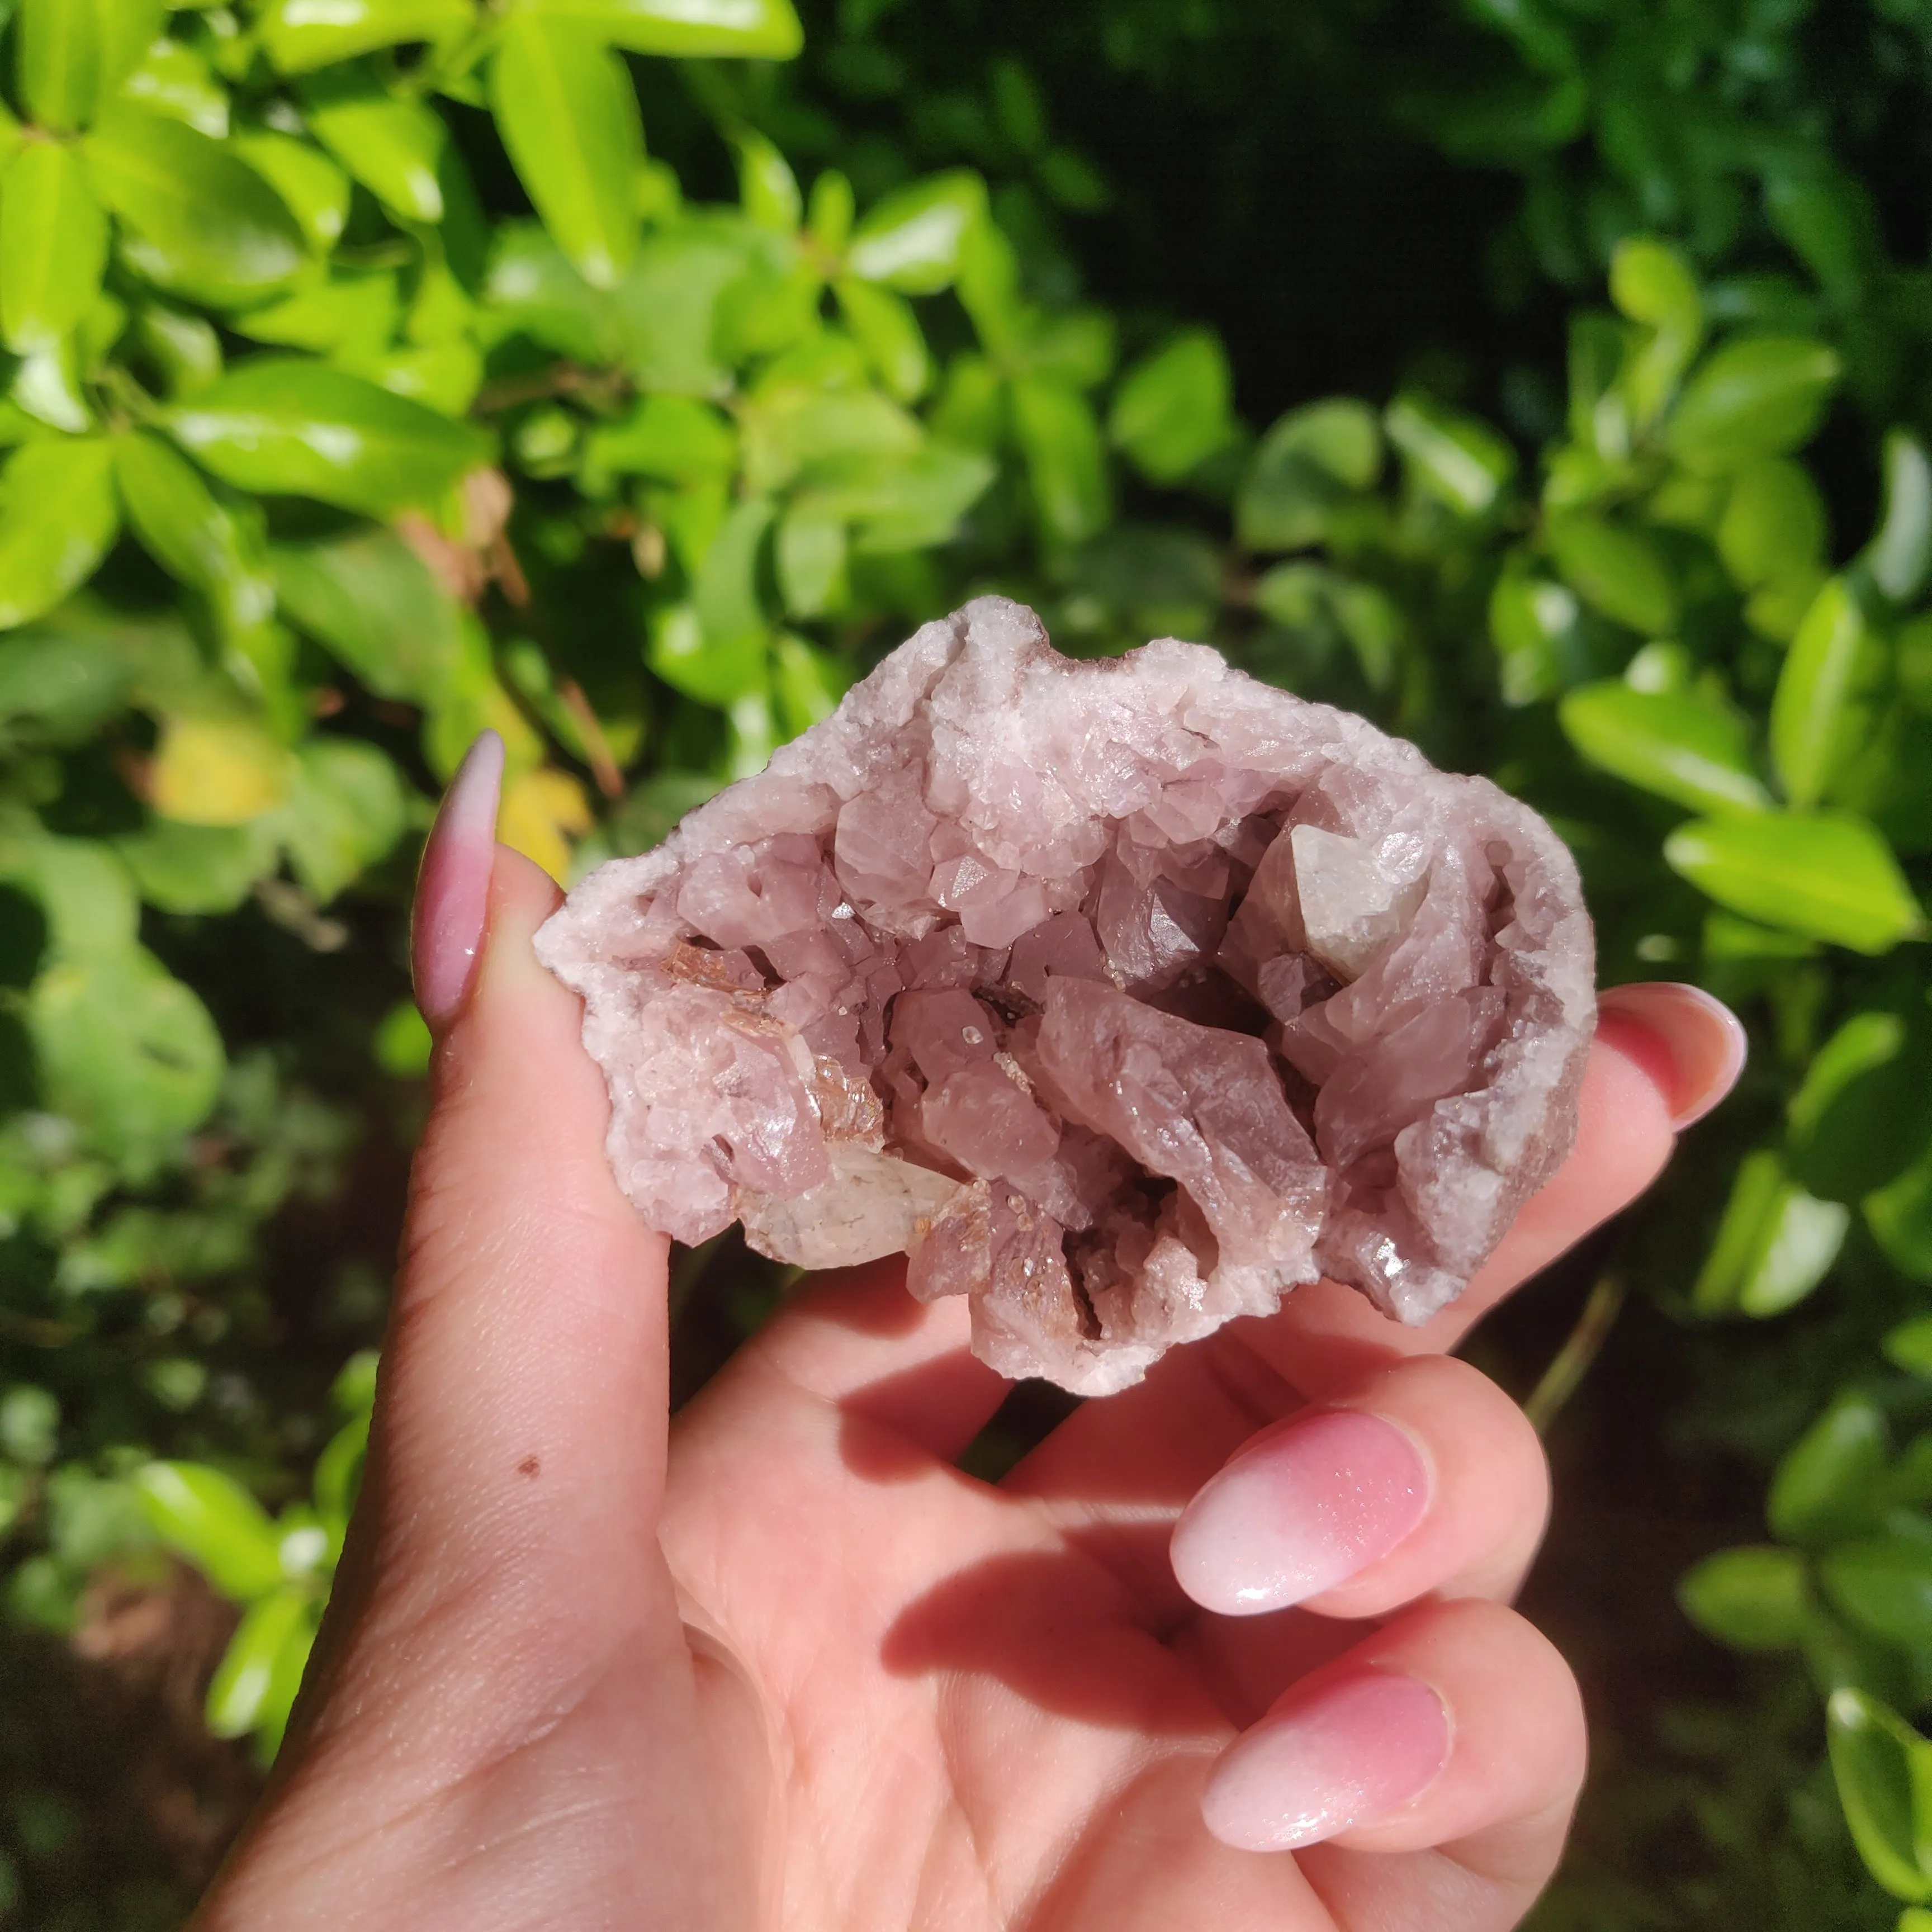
1171;1408;1429;1617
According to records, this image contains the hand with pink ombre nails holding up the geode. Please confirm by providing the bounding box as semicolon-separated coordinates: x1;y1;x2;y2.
197;742;1735;1932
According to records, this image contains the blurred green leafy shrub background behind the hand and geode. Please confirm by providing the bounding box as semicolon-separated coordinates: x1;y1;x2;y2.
0;0;1932;1932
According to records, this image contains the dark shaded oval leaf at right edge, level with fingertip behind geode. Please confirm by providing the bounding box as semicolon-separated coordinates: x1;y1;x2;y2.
1787;1010;1932;1202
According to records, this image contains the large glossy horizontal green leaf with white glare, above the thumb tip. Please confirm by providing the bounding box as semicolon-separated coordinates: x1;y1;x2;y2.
160;356;489;516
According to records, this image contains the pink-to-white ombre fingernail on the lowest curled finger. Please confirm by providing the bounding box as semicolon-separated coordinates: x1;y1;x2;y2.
1202;1671;1449;1851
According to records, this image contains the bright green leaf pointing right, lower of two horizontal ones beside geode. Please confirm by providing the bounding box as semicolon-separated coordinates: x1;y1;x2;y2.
1664;812;1924;954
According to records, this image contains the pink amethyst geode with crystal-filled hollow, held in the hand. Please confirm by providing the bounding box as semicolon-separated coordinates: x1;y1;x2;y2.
537;597;1596;1395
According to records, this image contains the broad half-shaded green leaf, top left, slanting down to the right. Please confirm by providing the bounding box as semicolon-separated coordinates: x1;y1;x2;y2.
83;106;307;307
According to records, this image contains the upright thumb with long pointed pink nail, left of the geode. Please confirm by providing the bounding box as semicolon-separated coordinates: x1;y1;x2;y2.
373;734;666;1594
